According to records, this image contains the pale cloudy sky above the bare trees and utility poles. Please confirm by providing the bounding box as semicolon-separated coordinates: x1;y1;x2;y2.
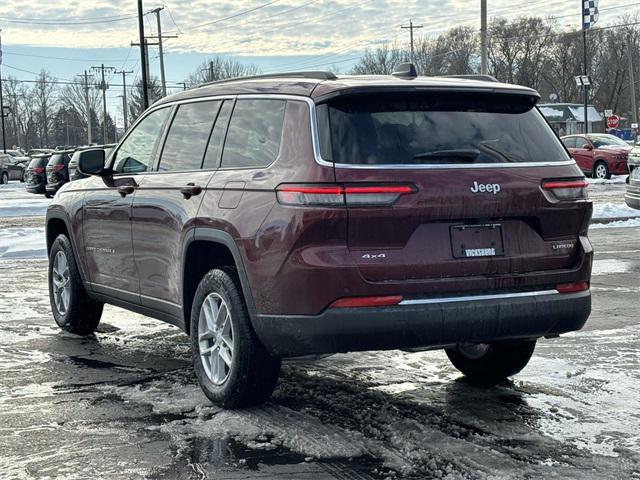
0;0;640;123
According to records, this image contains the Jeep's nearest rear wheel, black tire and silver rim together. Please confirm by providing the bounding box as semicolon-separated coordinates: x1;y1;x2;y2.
191;269;280;408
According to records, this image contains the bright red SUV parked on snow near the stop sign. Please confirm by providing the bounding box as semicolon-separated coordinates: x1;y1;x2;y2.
562;133;632;178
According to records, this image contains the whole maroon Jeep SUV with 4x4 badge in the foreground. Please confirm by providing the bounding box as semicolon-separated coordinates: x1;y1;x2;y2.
46;67;593;408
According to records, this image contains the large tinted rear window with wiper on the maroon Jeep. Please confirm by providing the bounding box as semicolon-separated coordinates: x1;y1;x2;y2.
318;92;570;165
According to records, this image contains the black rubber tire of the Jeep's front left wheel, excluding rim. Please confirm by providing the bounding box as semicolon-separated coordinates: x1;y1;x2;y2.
49;234;104;335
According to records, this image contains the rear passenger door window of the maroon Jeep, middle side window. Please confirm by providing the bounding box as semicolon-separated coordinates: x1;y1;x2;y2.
158;101;220;172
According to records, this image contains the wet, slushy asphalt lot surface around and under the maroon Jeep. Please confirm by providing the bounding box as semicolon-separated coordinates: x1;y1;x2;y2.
0;182;640;480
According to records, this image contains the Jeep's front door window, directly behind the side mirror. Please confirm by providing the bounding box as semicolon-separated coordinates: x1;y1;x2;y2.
111;108;171;173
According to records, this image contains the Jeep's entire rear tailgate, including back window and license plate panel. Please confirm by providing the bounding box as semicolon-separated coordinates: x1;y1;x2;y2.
319;93;591;283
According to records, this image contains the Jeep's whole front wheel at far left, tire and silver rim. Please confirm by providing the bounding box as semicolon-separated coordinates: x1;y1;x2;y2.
49;235;103;335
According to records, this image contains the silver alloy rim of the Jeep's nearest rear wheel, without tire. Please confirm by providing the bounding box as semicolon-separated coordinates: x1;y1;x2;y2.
198;293;233;385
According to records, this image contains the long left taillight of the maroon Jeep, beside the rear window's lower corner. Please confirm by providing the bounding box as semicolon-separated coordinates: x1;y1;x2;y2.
276;184;417;207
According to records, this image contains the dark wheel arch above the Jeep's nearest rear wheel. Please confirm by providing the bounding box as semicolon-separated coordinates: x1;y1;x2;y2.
182;227;256;333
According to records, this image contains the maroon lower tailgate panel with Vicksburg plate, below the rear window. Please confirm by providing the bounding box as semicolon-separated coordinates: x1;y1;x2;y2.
336;166;591;282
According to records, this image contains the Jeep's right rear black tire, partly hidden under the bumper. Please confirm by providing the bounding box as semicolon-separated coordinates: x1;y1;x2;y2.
447;340;536;386
